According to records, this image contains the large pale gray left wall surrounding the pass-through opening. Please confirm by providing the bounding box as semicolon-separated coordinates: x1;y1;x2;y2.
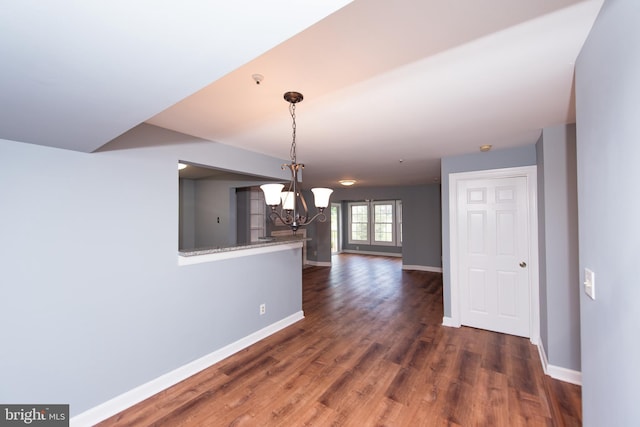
0;125;302;415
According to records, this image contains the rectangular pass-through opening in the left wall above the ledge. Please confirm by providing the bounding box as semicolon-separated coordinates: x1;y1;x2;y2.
178;161;277;251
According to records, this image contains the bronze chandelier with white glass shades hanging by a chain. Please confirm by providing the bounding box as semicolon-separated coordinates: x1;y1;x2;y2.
260;92;333;234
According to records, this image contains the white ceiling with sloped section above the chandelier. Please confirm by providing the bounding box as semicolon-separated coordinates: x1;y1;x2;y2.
0;0;603;187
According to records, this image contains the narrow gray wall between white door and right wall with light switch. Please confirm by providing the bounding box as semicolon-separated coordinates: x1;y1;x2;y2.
536;125;580;371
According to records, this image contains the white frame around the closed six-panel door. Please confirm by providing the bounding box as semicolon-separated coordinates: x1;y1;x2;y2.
448;166;540;345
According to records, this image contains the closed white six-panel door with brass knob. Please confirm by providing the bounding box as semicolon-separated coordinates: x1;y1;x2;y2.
456;176;531;337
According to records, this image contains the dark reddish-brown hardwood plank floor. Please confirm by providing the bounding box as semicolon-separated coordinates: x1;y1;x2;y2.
100;255;582;427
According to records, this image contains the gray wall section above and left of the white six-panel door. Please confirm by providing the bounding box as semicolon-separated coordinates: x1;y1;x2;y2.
441;145;536;317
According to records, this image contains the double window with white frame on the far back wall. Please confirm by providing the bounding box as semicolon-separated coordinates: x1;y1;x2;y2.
348;200;402;246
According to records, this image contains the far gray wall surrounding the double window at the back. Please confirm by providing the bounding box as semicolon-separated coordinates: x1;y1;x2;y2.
327;184;442;268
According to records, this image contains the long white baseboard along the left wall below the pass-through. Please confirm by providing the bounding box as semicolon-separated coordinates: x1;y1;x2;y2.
70;310;304;427
